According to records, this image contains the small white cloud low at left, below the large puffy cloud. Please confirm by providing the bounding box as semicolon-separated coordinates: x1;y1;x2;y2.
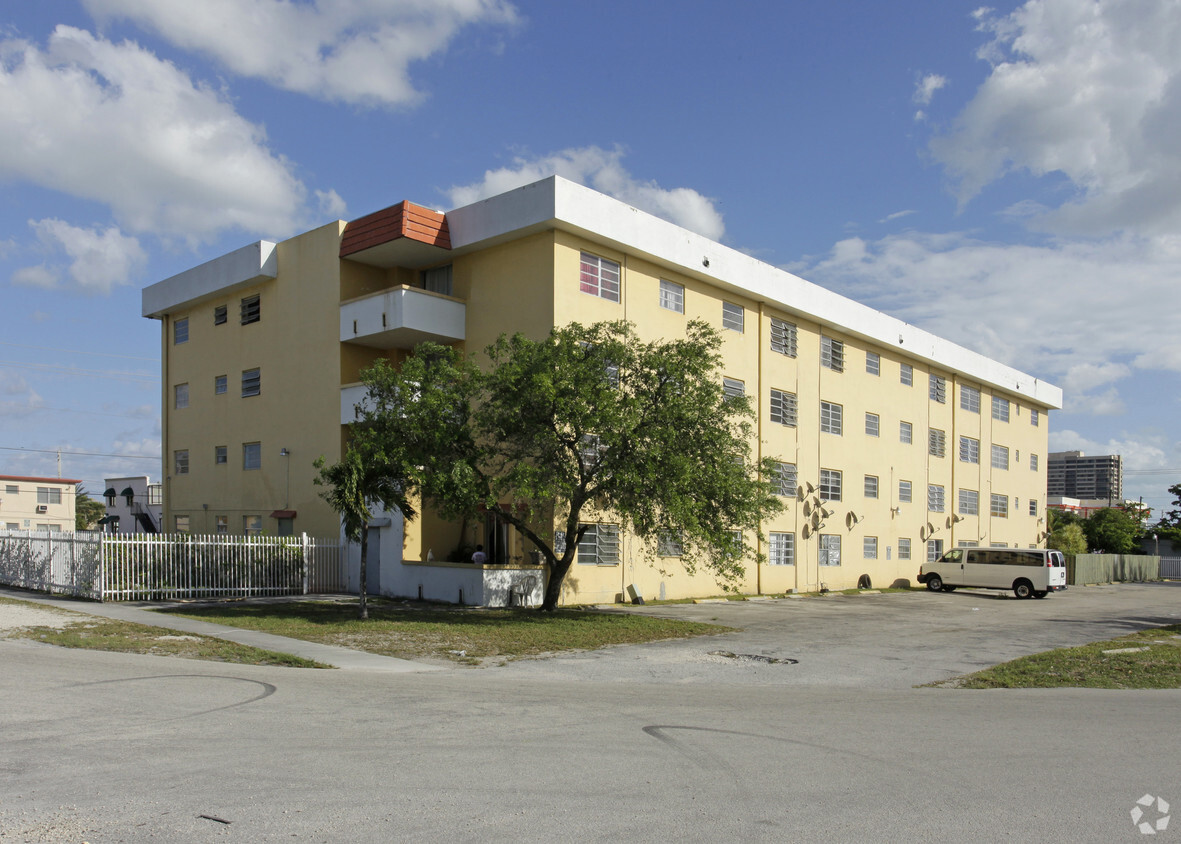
30;218;148;294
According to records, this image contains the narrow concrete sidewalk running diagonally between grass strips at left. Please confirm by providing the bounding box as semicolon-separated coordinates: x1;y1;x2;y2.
0;587;445;673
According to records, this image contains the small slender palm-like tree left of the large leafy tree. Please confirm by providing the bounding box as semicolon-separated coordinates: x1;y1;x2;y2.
313;443;415;619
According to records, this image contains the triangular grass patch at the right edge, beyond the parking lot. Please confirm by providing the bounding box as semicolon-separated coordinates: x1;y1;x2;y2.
932;624;1181;688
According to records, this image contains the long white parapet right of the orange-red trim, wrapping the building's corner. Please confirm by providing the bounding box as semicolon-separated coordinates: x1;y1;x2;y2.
446;176;1062;408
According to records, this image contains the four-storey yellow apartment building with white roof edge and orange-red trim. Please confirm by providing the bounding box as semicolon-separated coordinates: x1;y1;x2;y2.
143;177;1062;603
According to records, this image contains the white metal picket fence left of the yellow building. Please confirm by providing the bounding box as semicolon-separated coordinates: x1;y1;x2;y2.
0;531;346;601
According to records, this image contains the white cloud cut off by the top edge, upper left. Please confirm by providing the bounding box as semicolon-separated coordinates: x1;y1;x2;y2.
84;0;517;105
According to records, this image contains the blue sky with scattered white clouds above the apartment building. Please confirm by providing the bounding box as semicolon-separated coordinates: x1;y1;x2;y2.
0;0;1181;509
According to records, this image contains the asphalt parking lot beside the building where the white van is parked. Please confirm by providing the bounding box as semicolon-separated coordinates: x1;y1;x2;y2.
500;582;1181;688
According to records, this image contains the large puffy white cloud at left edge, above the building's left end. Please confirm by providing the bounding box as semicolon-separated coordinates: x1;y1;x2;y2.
0;25;307;242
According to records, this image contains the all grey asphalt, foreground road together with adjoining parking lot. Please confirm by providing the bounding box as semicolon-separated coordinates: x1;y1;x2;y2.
0;584;1181;844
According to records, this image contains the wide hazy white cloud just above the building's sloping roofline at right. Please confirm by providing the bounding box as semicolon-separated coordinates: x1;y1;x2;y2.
791;227;1181;390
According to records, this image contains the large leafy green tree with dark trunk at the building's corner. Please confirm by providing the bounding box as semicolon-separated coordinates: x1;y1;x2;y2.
357;321;782;610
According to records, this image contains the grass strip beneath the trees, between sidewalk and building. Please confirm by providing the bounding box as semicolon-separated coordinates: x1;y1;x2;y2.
157;598;731;665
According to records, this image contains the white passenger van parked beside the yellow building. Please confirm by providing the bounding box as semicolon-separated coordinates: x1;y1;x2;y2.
919;548;1066;597
